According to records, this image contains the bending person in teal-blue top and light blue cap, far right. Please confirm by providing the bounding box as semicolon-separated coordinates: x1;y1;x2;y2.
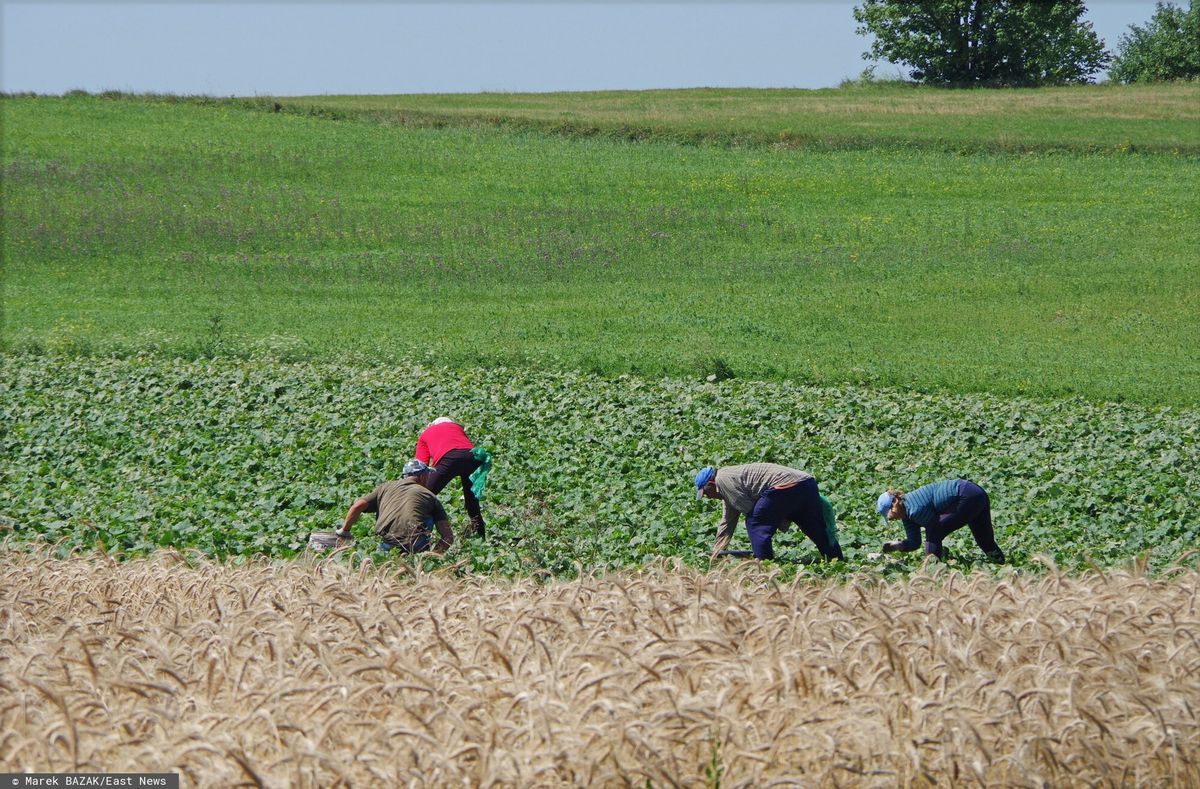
875;480;1004;565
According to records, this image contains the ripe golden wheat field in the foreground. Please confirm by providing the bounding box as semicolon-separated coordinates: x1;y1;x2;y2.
0;553;1200;787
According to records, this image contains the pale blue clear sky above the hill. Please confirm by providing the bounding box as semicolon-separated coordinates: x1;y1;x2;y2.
0;0;1161;96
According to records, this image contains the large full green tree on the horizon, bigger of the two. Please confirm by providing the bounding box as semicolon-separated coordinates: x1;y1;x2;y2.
854;0;1109;86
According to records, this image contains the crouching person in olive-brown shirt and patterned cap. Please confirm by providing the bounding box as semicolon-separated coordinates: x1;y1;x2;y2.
334;460;454;553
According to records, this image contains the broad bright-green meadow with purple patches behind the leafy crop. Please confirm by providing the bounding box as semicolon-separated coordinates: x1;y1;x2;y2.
7;97;1200;404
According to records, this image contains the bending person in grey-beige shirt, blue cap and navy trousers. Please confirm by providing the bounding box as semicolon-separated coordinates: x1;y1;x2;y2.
696;463;844;560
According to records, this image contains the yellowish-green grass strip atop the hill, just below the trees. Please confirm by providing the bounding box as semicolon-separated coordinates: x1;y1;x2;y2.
288;83;1200;155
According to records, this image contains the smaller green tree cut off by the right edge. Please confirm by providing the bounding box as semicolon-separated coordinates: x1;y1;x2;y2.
1109;0;1200;83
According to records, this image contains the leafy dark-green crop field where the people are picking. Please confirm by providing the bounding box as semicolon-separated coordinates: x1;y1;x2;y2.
0;355;1200;574
